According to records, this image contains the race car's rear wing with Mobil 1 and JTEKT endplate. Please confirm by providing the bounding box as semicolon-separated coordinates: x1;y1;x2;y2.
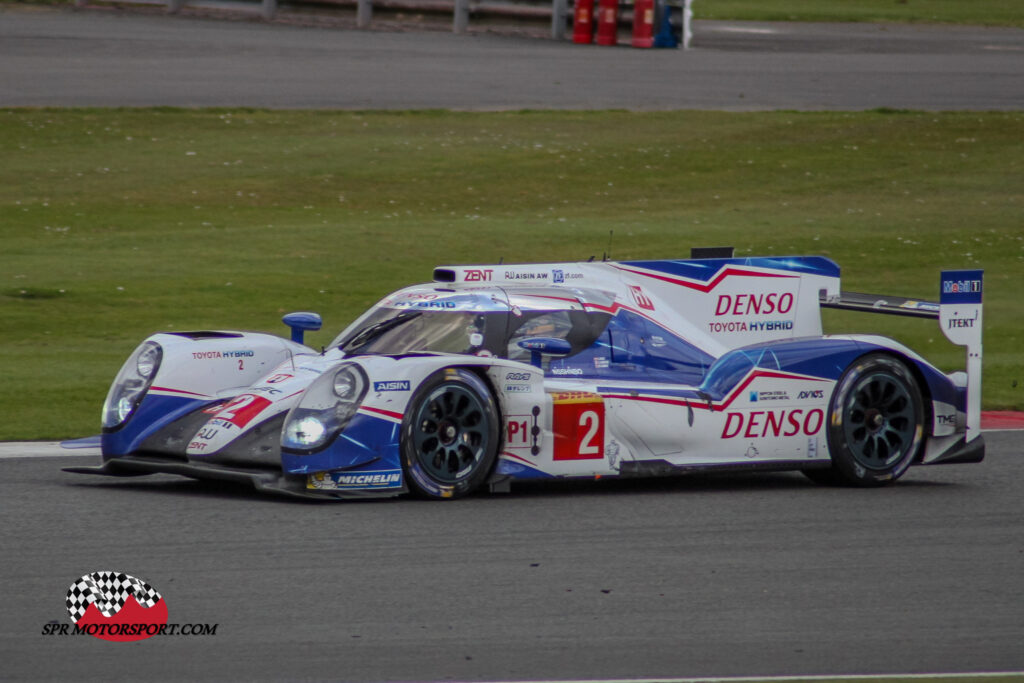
819;270;984;441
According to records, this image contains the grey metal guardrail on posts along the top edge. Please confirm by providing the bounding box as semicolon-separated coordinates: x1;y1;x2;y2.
74;0;692;47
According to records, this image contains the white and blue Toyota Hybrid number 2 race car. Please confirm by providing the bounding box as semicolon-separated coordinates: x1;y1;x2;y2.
71;250;984;499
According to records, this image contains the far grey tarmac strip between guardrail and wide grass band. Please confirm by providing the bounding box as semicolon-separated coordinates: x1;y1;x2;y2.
0;5;1024;110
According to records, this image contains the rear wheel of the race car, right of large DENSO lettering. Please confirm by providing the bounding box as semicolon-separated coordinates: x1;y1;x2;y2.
804;353;925;486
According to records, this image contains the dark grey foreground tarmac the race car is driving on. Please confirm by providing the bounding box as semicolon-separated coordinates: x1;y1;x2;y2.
0;432;1024;681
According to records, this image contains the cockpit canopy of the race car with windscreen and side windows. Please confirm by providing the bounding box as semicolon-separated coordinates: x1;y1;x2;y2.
332;285;714;385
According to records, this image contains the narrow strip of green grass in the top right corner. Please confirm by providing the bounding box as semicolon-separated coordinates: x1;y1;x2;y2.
693;0;1024;28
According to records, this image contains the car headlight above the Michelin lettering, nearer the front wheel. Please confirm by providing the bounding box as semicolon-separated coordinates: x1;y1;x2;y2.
281;362;369;454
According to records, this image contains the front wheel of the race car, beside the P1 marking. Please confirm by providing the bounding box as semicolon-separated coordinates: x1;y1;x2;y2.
401;368;501;499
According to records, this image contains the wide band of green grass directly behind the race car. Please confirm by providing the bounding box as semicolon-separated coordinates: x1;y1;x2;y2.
0;109;1024;439
